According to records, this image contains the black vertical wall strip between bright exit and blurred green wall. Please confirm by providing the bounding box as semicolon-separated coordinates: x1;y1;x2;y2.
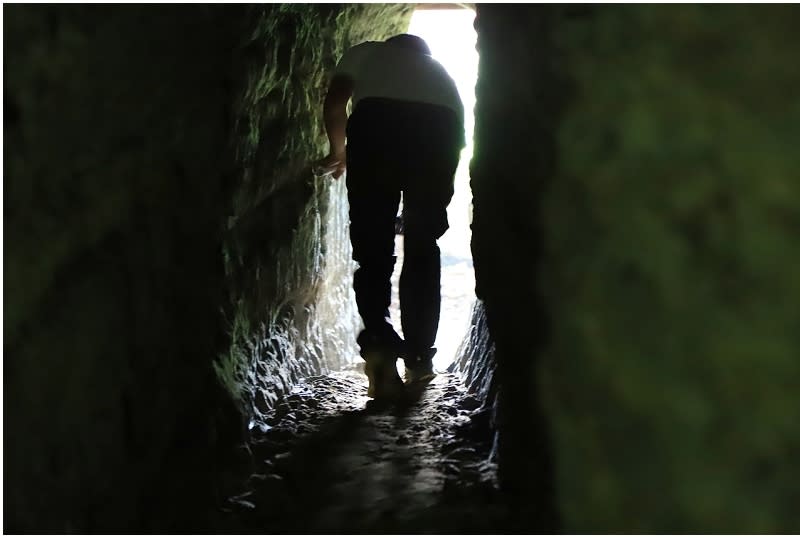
470;5;560;532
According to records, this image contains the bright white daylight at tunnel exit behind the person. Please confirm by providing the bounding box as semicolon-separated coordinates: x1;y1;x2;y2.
392;9;478;370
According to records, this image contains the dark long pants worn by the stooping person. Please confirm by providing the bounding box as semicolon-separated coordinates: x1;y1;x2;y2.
347;99;464;359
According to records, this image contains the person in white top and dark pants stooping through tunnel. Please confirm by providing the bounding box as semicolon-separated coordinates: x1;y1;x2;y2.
318;34;466;399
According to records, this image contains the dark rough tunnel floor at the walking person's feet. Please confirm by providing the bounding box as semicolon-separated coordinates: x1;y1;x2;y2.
220;372;509;534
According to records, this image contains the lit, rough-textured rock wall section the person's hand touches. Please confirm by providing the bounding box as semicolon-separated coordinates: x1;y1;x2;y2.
217;4;413;427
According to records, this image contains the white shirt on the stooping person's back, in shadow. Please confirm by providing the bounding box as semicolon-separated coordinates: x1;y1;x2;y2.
336;41;464;124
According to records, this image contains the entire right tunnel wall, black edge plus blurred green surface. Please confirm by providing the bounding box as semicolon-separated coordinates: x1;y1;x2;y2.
473;5;800;533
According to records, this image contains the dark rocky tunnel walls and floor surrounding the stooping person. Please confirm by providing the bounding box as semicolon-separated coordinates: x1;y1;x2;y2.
3;4;800;534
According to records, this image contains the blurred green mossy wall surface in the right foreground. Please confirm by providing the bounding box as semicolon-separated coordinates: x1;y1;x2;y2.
542;6;800;533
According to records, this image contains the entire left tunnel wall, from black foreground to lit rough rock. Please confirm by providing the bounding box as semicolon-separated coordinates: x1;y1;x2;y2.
3;4;410;533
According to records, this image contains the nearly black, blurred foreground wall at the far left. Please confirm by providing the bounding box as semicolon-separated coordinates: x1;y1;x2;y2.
3;5;244;532
